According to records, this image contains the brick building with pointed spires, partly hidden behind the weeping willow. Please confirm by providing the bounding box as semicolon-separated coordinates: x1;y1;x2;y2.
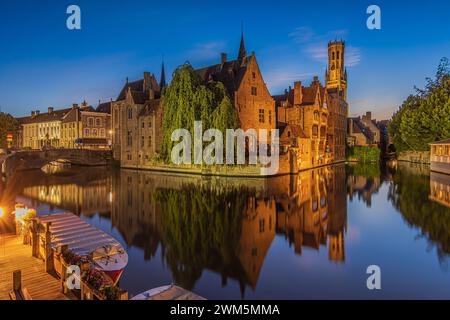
112;36;276;168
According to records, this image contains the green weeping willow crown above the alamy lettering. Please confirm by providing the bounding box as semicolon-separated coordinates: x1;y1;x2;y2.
162;64;239;162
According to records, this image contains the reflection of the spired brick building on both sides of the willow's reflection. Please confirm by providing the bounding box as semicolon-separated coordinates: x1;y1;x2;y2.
111;170;276;288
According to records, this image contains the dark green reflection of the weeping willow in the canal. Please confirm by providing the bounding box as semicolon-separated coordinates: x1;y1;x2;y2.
155;186;251;289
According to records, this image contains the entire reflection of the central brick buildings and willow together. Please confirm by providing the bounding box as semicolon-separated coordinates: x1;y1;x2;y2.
112;166;346;291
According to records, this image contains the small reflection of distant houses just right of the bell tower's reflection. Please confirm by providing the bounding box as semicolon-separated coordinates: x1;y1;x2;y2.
347;175;382;207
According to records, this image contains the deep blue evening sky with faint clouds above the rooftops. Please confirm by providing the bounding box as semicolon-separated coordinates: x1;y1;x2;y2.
0;0;450;119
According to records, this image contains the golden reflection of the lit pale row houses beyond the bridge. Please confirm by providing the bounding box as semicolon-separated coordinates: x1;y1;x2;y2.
22;178;111;216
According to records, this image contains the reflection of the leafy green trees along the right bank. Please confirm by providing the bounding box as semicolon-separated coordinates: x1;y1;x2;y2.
388;167;450;270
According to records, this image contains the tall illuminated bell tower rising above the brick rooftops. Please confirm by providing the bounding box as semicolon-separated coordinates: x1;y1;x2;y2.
325;40;347;100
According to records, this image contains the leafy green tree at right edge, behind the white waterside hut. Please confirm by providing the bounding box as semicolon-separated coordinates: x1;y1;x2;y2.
389;58;450;151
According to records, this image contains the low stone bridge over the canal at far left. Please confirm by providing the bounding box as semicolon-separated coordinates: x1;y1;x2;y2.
1;149;112;178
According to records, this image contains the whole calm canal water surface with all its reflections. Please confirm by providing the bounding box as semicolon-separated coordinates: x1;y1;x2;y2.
2;164;450;299
